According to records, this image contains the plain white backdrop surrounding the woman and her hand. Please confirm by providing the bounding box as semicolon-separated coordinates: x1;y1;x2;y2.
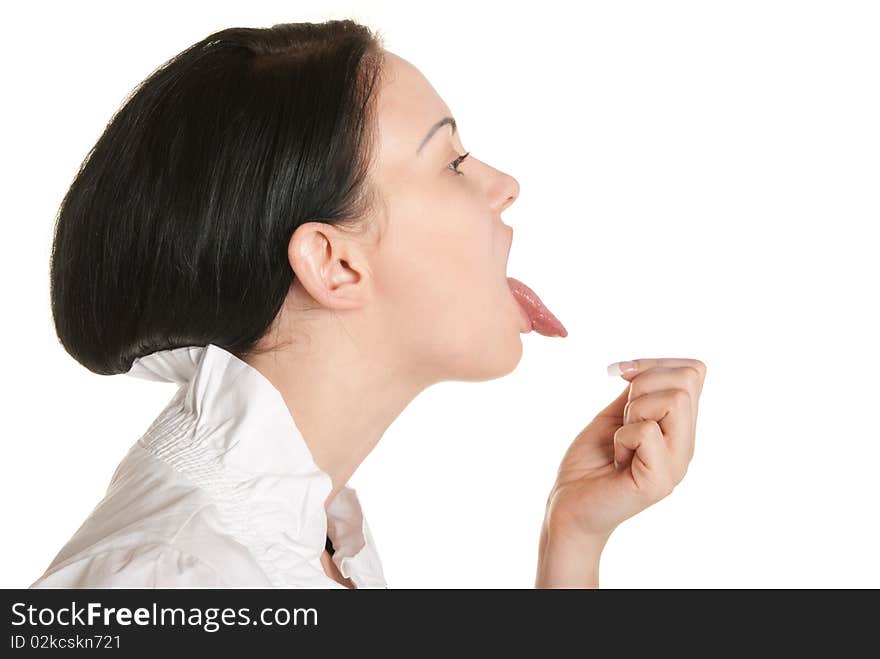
0;0;880;588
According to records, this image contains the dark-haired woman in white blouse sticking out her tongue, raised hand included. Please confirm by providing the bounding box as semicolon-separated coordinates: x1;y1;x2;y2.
32;20;705;588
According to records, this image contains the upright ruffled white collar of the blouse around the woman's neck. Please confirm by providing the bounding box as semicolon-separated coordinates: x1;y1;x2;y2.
127;344;384;588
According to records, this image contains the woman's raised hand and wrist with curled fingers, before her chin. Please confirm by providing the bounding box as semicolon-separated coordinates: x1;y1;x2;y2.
536;358;706;588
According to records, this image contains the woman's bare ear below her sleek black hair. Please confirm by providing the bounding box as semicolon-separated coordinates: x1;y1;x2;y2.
287;222;367;309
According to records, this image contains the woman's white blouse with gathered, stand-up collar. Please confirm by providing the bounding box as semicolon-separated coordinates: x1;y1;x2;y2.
30;344;387;588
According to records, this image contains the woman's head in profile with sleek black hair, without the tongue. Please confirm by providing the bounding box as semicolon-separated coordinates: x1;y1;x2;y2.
51;20;524;386
